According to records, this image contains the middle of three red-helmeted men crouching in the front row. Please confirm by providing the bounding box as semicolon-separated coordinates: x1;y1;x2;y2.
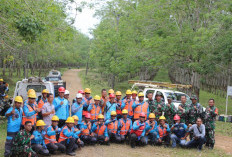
130;112;147;148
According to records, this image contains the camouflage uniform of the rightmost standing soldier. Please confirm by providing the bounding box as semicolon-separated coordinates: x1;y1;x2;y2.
204;106;218;148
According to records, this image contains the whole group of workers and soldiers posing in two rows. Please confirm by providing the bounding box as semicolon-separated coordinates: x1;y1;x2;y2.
5;87;218;157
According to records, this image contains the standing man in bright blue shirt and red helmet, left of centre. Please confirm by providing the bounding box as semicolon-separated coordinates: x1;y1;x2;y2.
53;87;69;128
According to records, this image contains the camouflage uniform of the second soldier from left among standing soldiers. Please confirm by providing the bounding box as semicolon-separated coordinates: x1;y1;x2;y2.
164;103;176;126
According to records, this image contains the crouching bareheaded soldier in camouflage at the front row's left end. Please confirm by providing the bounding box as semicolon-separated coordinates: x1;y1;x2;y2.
11;121;37;157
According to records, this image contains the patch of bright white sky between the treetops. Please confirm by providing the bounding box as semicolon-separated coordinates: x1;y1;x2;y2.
70;0;103;38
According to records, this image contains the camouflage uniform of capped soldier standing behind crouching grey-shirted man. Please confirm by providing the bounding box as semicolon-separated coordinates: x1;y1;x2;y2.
188;103;203;124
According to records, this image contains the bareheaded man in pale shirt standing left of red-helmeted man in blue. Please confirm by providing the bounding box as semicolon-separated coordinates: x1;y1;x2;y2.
42;93;55;129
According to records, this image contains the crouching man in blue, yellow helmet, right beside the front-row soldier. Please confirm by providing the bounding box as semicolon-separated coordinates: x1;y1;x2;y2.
31;120;50;156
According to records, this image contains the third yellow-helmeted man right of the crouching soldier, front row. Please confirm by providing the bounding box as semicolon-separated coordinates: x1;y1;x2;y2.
58;117;78;156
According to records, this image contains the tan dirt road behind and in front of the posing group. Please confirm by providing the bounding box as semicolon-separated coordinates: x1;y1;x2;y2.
56;69;232;157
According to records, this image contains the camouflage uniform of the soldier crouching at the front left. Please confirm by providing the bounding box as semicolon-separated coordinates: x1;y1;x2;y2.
12;130;37;157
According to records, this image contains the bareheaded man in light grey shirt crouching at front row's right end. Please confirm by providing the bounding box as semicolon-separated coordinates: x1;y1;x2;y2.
186;118;206;151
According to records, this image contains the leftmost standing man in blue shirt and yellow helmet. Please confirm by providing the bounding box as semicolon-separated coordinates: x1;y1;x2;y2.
4;96;23;157
